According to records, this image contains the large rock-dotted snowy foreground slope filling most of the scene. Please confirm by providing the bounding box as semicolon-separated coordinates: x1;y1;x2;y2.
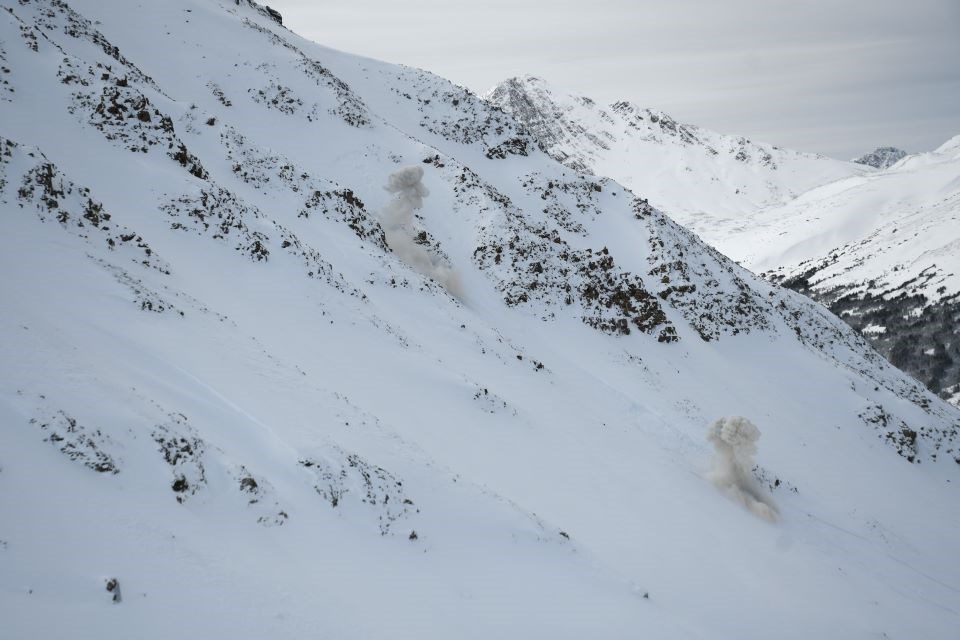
0;0;960;638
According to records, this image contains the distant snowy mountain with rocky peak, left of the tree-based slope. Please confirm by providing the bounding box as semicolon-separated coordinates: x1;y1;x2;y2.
486;76;870;238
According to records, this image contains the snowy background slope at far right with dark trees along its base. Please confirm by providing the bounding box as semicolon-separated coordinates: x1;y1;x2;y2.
744;136;960;403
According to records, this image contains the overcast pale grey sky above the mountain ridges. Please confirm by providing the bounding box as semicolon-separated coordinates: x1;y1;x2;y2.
270;0;960;159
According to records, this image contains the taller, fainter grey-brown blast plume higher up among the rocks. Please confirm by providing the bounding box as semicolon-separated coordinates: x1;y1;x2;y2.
380;165;462;298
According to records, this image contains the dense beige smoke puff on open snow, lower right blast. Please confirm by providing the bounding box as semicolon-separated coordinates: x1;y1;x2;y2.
707;416;779;522
